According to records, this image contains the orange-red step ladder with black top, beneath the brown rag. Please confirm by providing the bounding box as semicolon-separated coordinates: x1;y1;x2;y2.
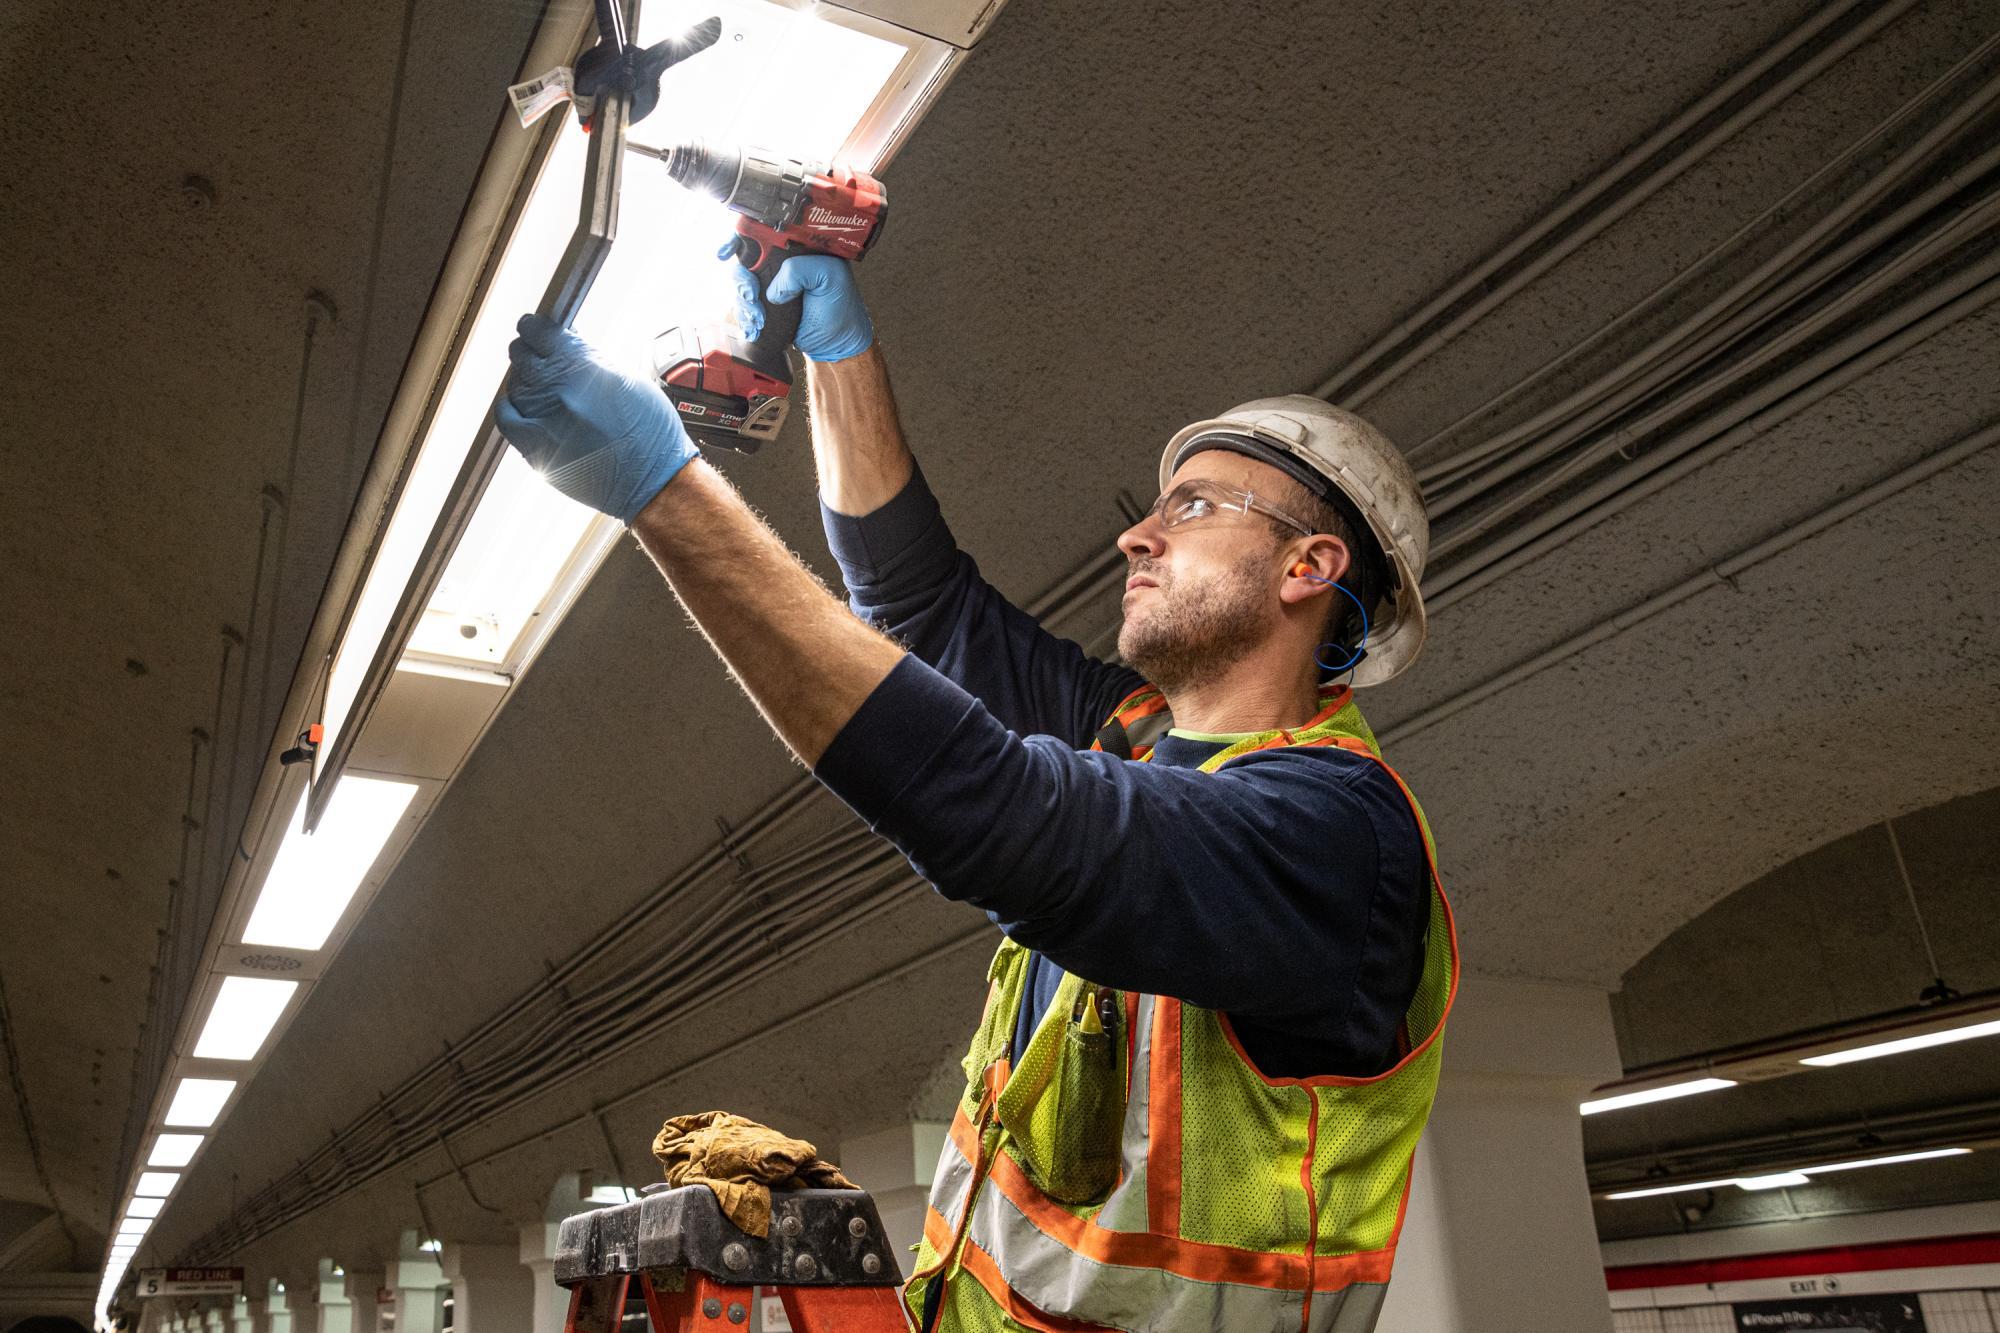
556;1185;906;1333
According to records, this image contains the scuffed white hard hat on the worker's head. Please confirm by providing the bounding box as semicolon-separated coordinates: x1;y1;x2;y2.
1160;394;1430;685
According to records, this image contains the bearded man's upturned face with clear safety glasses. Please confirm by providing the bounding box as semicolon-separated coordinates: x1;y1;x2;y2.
1118;448;1290;691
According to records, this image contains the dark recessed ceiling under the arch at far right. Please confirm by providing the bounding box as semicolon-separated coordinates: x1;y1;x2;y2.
1584;789;2000;1237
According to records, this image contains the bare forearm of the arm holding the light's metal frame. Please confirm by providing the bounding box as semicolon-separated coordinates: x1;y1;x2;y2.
632;458;902;767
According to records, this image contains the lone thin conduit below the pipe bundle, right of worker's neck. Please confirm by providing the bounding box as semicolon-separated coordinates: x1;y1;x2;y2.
1382;422;2000;741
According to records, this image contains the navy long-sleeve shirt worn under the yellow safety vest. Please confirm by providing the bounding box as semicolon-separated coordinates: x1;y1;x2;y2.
816;462;1430;1077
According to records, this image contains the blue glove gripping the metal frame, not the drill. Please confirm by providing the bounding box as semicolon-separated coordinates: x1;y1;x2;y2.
498;314;702;522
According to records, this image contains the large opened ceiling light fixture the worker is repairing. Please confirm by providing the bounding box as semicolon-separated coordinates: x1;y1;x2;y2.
308;0;968;808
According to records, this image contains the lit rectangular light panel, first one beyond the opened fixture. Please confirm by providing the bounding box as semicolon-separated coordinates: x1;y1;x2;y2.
244;775;416;949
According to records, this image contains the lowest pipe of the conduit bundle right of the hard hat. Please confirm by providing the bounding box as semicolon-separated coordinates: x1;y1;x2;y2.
1426;252;2000;610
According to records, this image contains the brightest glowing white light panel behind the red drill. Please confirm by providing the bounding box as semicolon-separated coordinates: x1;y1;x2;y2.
386;0;938;680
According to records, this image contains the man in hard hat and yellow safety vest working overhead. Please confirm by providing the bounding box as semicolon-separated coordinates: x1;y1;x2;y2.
500;256;1458;1333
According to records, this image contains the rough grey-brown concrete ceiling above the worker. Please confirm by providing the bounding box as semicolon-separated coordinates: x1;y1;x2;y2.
0;0;2000;1271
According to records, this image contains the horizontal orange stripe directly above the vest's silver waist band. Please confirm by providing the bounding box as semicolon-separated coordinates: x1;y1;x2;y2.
952;1121;1396;1291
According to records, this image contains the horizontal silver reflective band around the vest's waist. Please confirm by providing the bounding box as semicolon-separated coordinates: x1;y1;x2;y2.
972;1168;1312;1333
